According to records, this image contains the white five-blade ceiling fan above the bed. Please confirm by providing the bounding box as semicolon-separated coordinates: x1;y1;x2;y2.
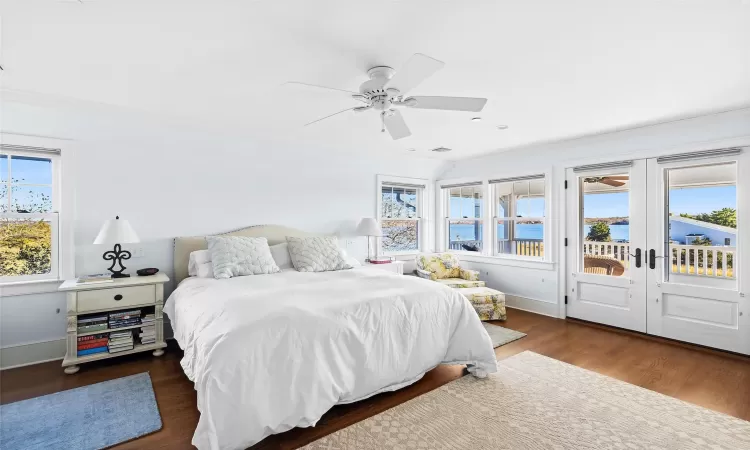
284;53;487;140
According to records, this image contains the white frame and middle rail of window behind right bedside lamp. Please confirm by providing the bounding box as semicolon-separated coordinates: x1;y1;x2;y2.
375;175;432;258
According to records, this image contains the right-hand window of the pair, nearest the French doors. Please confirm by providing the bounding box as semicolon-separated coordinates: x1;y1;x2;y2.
489;175;546;258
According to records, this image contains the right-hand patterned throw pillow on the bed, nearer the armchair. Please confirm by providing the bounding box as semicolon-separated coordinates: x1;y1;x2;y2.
286;236;352;272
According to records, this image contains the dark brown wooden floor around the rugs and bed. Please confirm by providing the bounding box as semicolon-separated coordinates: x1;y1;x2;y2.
0;310;750;449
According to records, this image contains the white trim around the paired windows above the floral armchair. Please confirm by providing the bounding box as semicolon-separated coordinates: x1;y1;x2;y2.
435;168;555;270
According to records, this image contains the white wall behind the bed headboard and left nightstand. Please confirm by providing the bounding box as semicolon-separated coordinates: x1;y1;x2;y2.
0;96;450;366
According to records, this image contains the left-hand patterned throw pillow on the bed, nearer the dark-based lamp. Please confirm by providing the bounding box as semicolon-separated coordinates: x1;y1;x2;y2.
206;236;280;278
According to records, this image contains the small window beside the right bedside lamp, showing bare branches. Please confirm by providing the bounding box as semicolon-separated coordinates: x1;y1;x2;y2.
379;180;425;253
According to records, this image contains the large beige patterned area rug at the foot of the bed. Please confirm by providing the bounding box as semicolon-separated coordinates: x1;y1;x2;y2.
304;351;750;450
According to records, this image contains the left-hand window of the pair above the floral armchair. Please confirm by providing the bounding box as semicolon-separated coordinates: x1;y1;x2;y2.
443;182;485;252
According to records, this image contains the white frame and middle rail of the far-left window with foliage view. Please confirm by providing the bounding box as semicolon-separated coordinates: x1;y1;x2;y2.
0;133;74;288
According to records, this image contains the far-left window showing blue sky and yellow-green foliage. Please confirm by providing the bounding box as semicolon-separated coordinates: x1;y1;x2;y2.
0;146;60;283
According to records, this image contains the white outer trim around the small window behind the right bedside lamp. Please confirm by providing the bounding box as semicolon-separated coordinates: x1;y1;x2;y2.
375;175;433;255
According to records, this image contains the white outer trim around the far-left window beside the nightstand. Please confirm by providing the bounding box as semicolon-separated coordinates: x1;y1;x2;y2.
0;133;75;296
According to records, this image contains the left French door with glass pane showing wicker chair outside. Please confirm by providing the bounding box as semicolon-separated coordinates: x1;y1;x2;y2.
566;160;646;332
